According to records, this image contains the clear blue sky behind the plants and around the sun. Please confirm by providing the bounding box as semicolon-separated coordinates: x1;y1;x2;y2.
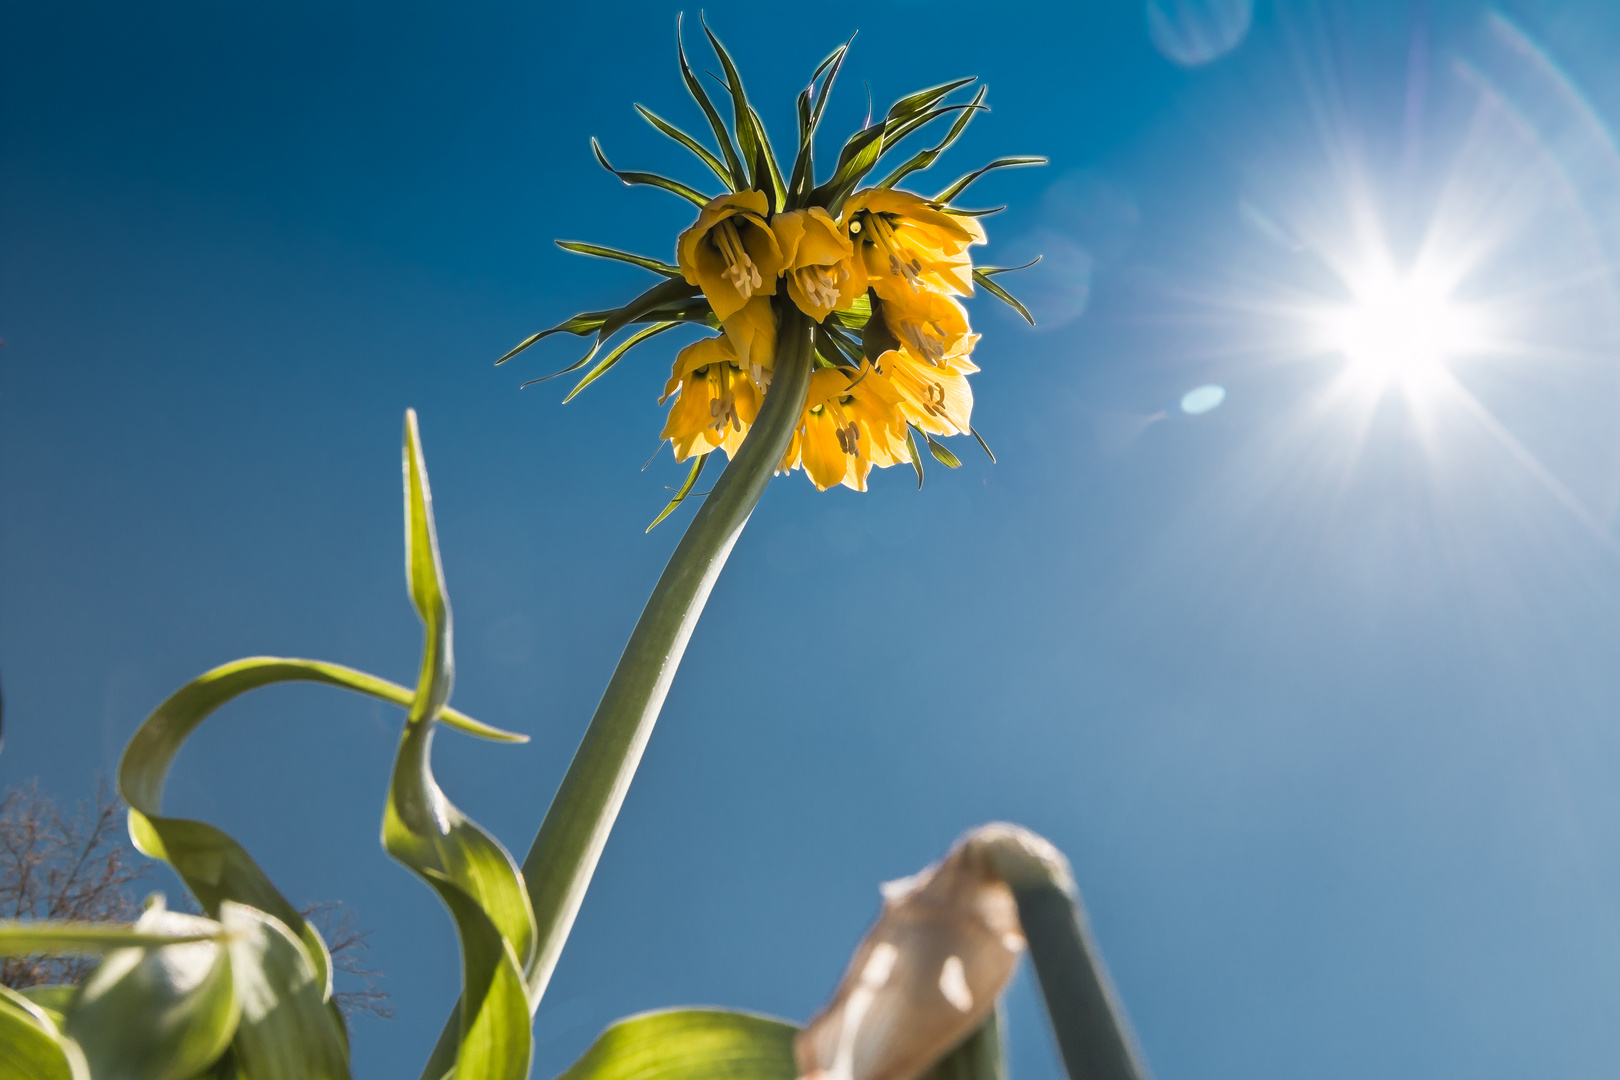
9;0;1620;1080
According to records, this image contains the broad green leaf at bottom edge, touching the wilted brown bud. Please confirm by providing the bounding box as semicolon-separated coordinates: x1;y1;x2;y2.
559;1009;799;1080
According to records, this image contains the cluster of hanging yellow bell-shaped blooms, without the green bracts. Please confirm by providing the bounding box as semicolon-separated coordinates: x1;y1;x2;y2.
663;188;985;491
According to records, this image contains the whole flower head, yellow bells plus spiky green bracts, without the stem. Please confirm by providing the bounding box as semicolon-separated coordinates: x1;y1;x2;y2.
497;26;1045;525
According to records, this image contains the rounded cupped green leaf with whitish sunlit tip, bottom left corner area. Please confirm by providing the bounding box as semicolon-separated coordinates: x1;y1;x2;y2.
63;904;241;1080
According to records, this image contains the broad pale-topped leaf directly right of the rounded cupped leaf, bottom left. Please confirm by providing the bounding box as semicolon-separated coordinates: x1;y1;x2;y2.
220;900;348;1080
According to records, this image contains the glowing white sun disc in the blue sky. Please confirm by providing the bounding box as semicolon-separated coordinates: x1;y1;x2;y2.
1319;267;1481;381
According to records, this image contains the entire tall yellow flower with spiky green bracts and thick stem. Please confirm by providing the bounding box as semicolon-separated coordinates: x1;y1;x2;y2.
453;28;1043;1062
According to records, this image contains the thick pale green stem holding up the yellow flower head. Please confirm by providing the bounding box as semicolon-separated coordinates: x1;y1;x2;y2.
423;303;815;1080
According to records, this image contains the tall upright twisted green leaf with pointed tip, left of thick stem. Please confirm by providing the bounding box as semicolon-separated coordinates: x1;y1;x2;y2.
392;411;535;1080
